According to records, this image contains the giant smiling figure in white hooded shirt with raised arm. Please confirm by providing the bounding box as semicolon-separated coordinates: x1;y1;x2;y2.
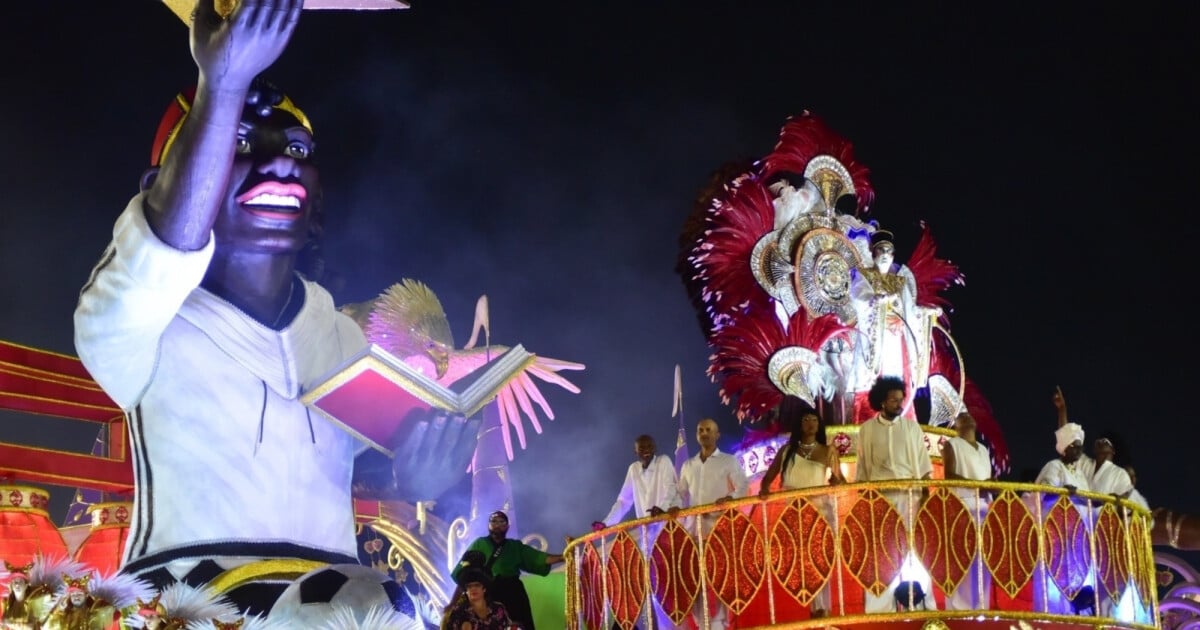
74;0;479;612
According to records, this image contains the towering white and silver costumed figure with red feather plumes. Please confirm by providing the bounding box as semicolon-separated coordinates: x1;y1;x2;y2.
677;112;1008;470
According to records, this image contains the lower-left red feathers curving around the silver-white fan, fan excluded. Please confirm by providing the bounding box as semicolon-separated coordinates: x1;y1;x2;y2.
708;308;851;420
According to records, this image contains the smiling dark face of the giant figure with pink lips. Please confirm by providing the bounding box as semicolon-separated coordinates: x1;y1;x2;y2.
212;107;320;256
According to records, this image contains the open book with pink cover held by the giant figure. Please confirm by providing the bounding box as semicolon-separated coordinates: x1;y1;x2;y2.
300;343;536;455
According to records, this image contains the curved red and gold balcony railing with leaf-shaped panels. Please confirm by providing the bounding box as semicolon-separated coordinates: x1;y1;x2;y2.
564;480;1158;630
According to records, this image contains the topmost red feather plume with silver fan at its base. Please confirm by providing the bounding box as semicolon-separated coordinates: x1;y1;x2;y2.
761;112;875;215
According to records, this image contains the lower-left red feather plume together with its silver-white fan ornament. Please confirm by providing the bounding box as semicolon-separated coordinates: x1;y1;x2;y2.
708;308;852;421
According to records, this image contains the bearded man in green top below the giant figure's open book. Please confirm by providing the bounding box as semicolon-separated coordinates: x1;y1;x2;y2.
450;511;563;630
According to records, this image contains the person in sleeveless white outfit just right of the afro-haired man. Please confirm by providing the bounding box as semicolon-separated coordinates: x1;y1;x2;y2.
942;412;992;611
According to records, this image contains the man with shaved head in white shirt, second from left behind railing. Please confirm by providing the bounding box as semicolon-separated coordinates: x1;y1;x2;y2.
679;418;749;630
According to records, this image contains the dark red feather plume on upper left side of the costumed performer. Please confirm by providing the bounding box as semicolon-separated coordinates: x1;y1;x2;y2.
689;175;775;328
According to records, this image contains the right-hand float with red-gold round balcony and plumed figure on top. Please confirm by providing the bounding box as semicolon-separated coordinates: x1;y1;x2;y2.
564;113;1180;630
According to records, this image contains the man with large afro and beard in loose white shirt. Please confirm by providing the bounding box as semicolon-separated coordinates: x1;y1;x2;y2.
856;377;934;613
